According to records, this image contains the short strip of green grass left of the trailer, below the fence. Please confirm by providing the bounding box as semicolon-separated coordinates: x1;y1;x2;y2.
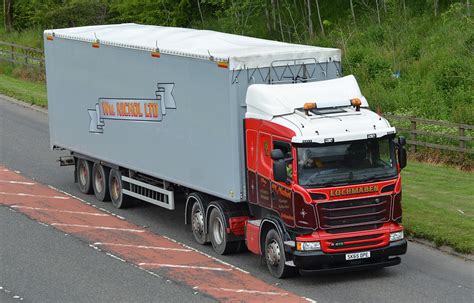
0;74;48;107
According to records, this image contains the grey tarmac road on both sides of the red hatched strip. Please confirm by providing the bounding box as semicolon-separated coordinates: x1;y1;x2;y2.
0;98;474;302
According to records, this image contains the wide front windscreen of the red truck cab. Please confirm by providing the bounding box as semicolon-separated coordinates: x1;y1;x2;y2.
297;138;397;187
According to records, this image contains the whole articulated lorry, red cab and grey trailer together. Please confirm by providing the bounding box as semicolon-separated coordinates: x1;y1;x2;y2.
44;24;407;277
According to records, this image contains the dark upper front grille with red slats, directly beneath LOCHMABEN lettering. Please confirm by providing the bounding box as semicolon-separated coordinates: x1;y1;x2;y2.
317;196;391;232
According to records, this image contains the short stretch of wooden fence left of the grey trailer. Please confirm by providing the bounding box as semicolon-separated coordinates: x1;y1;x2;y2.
0;41;44;71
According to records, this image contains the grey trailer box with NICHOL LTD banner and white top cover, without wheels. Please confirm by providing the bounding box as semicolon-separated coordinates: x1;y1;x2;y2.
44;24;341;208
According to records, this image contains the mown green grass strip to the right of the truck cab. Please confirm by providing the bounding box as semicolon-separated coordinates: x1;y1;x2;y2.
402;161;474;253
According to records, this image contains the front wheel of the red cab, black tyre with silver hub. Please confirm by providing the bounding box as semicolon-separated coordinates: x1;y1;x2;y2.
264;229;298;279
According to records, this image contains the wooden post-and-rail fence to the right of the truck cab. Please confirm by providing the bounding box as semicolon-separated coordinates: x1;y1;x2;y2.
383;114;474;154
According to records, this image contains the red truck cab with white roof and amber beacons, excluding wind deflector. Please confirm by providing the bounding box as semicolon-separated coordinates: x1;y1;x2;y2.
241;76;407;277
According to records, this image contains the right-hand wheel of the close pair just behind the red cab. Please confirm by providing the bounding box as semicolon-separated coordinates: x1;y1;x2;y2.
208;208;241;255
